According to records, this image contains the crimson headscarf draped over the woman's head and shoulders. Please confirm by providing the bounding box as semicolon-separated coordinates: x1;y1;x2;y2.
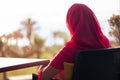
66;4;110;49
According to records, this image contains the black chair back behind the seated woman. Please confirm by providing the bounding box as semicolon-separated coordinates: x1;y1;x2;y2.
72;48;120;80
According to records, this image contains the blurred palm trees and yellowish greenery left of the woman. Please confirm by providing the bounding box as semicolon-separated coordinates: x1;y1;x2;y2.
0;18;69;79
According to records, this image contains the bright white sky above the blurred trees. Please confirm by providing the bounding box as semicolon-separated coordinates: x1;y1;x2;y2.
0;0;119;45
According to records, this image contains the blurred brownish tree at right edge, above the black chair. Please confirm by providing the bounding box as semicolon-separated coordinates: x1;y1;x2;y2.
108;14;120;47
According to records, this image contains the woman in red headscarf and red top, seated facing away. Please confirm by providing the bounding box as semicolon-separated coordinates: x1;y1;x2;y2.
38;3;110;80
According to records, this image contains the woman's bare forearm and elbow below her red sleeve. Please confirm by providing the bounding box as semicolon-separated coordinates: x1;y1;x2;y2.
41;66;61;80
